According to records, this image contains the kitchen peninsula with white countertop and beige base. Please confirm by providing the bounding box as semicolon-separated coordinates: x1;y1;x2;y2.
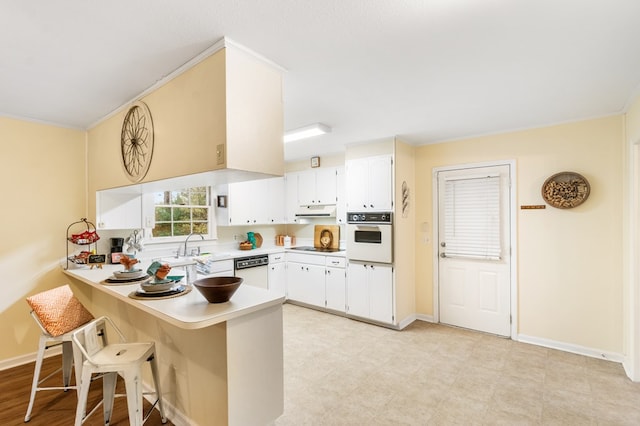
65;265;284;426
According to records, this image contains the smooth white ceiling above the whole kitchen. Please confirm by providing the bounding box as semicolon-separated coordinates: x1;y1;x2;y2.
0;0;640;160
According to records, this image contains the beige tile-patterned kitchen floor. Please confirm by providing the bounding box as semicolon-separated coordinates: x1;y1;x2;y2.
275;304;640;426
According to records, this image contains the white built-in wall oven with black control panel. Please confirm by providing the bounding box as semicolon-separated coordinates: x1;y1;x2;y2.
346;212;393;263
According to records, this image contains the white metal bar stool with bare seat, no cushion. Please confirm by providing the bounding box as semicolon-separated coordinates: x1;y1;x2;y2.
73;317;167;426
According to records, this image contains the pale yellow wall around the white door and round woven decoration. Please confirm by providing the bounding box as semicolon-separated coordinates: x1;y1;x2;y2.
416;116;624;354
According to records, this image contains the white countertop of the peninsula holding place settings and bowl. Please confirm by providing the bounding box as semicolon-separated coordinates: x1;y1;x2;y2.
64;263;284;329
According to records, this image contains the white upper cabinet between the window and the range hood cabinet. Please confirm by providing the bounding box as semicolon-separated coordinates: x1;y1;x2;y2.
217;178;285;226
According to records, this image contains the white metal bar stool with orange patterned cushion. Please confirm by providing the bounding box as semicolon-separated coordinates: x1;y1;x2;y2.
24;285;93;422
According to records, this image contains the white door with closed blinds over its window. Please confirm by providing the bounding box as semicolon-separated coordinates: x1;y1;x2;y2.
437;165;511;337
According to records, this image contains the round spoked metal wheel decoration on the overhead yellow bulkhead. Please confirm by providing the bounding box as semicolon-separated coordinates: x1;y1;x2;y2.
120;101;153;182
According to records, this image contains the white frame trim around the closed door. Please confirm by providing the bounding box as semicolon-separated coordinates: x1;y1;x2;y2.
431;160;518;340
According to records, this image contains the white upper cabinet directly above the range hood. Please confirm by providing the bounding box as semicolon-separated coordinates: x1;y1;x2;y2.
298;167;337;206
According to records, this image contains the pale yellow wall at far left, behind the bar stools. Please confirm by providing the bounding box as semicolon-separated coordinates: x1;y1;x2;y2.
0;117;86;360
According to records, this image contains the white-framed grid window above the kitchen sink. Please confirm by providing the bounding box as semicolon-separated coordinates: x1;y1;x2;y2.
151;186;212;239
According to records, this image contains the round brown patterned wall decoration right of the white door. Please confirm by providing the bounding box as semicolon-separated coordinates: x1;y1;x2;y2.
542;172;591;209
